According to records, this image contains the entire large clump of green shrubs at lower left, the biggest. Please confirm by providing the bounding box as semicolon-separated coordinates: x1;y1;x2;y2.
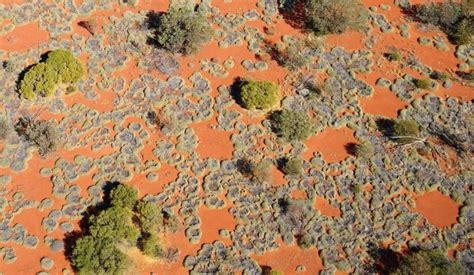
70;184;176;274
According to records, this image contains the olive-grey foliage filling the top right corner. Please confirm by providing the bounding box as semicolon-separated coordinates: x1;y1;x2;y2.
413;0;474;45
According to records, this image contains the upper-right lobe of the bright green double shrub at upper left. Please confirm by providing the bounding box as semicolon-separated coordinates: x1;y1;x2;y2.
46;49;84;83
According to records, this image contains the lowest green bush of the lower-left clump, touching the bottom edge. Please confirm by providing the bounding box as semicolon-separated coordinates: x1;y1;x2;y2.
71;236;131;275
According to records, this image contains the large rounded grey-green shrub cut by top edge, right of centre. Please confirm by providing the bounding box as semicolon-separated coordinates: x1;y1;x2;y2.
302;0;369;35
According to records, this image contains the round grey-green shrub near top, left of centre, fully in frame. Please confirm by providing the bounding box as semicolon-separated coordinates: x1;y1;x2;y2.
148;7;213;55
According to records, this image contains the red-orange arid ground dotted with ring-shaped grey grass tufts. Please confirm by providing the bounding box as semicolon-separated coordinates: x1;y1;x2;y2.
0;0;474;274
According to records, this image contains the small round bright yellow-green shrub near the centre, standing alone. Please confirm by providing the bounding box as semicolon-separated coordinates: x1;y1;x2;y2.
240;80;280;110
